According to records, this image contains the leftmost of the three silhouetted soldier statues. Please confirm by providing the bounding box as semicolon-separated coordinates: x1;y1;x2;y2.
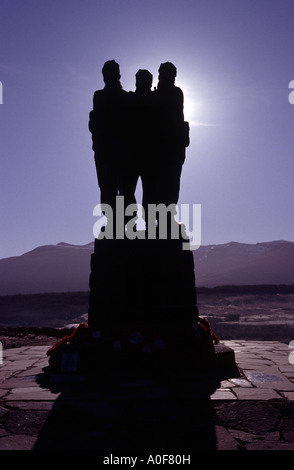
89;60;128;227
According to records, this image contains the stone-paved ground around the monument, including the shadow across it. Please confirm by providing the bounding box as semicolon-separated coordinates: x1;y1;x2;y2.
0;340;294;451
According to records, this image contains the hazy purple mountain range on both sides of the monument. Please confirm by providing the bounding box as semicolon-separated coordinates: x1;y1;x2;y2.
0;240;294;295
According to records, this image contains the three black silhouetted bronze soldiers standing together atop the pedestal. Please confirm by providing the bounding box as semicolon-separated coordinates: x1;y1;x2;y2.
89;60;189;233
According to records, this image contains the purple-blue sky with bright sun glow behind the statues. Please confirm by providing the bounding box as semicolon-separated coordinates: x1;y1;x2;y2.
0;0;294;258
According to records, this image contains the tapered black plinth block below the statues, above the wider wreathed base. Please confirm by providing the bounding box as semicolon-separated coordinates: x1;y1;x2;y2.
88;234;198;330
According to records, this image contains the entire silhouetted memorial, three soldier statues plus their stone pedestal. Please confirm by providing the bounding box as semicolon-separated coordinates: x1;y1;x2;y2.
48;60;237;373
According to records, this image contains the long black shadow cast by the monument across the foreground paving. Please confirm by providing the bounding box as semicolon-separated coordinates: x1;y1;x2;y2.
34;367;220;454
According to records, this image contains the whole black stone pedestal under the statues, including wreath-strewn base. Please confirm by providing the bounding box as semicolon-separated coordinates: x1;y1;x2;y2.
51;233;240;375
